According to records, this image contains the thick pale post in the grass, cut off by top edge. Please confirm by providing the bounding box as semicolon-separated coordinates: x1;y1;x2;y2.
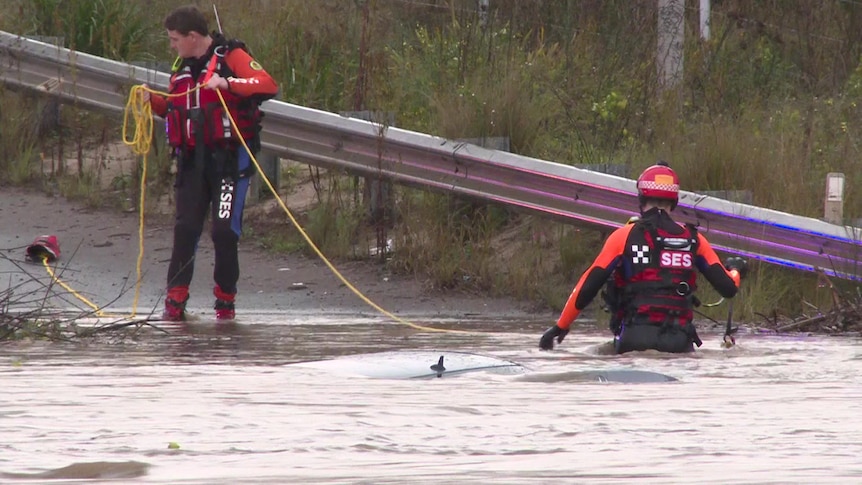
656;0;685;90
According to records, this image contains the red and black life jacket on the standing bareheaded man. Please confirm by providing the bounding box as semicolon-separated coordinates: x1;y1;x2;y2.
165;36;263;148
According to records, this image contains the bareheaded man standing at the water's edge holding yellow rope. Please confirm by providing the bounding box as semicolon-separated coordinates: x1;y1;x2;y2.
149;6;278;321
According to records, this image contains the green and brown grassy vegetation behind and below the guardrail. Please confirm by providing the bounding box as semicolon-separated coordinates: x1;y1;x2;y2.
0;0;862;319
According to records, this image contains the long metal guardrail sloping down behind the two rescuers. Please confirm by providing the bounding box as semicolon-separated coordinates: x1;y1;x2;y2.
0;32;862;280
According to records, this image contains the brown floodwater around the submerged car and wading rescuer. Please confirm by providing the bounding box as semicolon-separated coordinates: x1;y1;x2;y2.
0;314;862;484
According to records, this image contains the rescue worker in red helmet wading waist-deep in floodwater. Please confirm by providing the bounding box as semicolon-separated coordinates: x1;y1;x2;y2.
539;162;747;354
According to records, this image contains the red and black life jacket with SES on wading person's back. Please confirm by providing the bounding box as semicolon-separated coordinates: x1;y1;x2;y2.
619;222;698;326
